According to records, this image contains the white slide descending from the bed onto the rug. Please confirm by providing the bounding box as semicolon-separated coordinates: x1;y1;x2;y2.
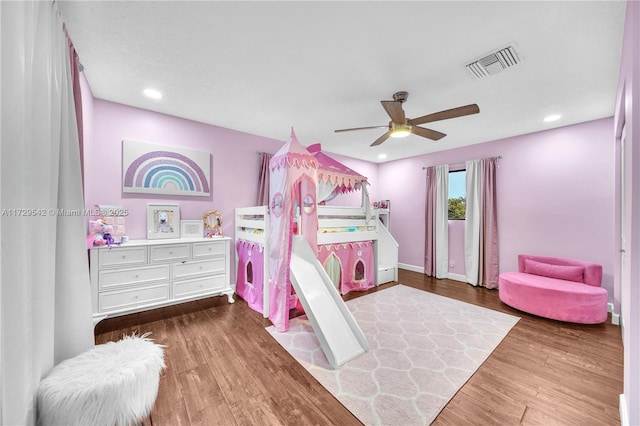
291;235;369;368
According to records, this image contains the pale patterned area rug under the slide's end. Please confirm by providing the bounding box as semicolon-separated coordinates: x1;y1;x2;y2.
267;285;520;426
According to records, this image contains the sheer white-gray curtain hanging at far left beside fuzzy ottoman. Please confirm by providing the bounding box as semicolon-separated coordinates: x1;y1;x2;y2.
0;1;94;425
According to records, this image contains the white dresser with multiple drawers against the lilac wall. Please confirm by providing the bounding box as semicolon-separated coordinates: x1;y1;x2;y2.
90;237;234;325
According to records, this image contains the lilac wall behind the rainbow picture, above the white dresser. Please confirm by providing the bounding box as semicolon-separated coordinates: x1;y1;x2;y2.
85;99;283;239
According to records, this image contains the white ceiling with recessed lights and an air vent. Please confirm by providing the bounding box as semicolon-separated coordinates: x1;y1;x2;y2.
59;1;626;162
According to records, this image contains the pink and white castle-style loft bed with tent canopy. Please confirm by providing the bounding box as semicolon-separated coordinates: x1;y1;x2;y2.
235;131;392;331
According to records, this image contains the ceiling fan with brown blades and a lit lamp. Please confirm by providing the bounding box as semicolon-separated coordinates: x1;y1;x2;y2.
335;92;480;146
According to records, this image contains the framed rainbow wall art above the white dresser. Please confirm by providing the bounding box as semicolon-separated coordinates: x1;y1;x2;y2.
122;139;211;197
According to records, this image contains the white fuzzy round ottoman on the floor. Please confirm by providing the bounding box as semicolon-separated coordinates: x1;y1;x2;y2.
38;334;164;426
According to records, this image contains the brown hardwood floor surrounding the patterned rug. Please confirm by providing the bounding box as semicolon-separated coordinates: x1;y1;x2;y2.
95;270;623;426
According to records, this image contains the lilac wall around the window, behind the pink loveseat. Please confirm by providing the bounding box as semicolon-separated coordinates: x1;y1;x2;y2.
377;118;614;297
